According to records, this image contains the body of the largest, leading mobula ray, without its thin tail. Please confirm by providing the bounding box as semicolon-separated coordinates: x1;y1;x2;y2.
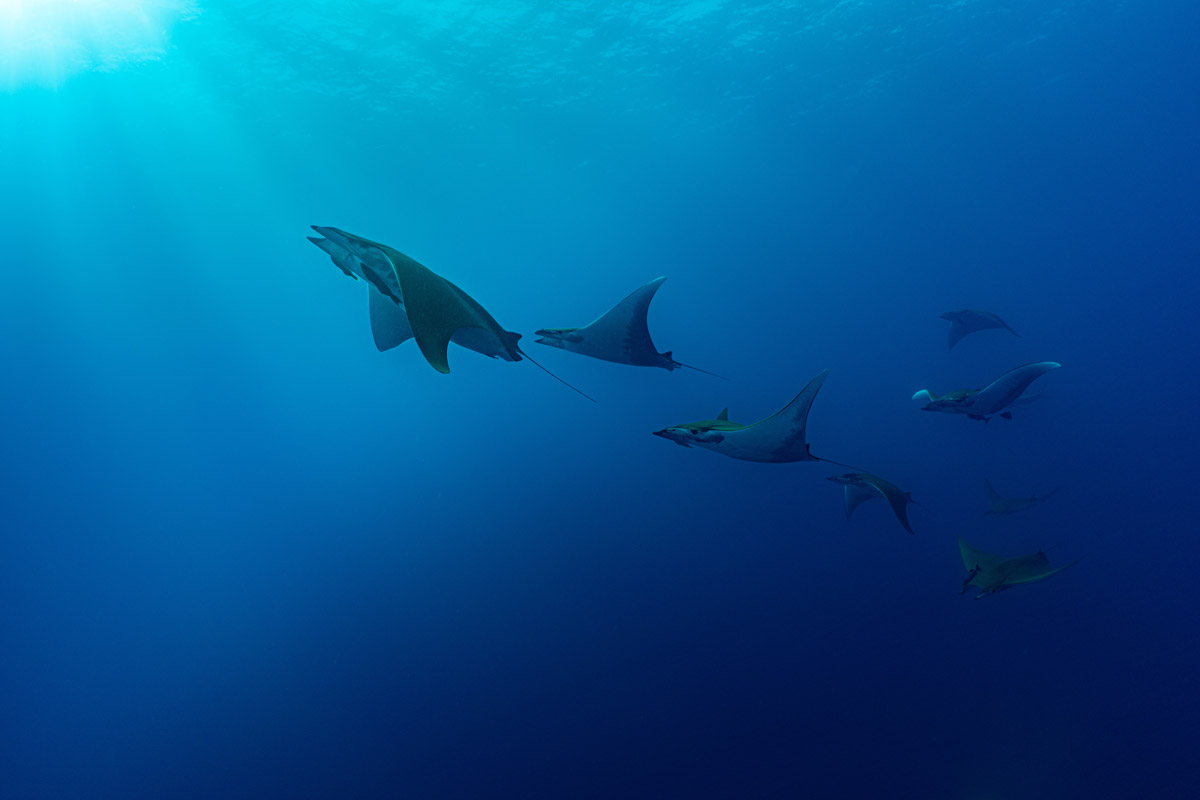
308;225;523;373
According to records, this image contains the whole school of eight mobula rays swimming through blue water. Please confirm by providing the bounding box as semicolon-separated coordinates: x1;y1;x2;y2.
308;225;1074;597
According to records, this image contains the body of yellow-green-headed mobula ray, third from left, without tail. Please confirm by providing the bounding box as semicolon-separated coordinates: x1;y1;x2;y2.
654;369;829;463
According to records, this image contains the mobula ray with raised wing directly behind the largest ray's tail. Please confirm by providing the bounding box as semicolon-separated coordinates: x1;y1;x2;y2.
536;277;720;378
